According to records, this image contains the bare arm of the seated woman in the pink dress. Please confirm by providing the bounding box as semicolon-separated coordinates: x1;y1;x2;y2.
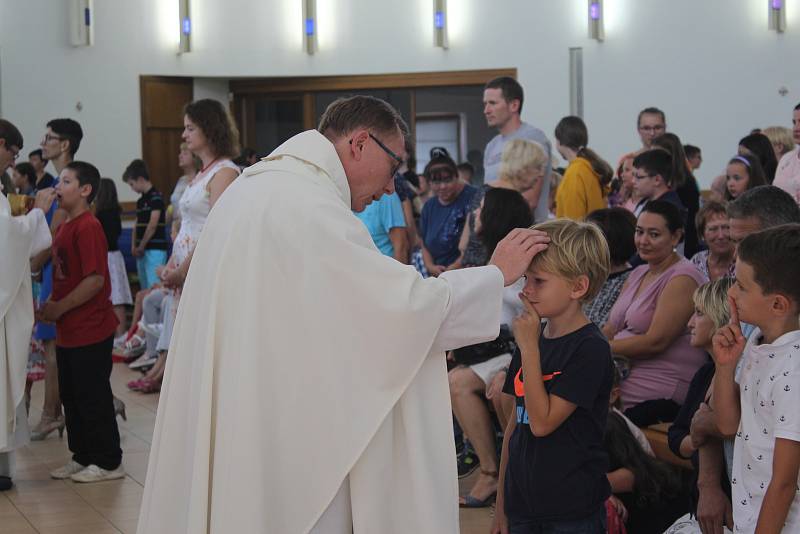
610;276;697;359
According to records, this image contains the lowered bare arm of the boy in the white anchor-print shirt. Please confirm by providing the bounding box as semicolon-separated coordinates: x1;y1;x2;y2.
756;438;800;534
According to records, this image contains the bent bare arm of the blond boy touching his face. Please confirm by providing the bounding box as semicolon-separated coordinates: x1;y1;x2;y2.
514;296;577;437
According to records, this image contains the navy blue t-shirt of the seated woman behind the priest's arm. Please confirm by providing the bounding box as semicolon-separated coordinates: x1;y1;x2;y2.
420;185;477;267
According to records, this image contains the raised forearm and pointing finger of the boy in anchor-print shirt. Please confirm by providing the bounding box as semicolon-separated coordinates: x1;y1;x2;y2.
711;297;746;435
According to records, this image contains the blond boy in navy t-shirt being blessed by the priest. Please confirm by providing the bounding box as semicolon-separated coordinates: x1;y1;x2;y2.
492;219;613;534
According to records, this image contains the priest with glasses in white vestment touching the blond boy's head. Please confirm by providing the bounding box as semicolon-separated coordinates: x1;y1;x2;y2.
138;96;547;534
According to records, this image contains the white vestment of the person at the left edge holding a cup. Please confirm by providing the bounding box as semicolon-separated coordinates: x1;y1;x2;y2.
0;199;51;452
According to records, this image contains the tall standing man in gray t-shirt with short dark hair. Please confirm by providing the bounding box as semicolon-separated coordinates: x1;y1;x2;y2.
483;76;552;222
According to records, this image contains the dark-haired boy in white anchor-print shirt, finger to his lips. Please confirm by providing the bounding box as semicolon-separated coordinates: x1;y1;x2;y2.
713;224;800;533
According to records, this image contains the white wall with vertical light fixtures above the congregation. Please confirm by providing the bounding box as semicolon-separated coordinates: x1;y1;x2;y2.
0;0;800;200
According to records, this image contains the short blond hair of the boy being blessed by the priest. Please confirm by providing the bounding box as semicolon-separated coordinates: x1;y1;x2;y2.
530;219;611;302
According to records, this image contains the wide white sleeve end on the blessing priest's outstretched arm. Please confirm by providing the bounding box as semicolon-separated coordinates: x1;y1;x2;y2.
431;265;504;352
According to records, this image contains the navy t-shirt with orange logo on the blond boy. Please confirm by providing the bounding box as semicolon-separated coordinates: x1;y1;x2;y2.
503;323;614;525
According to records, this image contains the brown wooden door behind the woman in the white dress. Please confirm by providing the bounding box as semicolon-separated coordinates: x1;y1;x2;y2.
139;76;193;205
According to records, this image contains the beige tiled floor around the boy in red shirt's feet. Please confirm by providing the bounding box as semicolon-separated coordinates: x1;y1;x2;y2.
0;364;491;534
